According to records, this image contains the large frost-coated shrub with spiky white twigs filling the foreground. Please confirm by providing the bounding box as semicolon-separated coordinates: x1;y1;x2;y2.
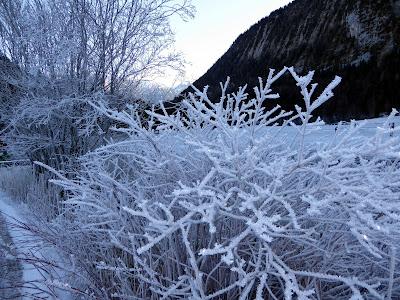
44;68;400;300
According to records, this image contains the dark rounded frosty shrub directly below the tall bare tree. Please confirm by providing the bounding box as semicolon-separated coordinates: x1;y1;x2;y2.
3;92;104;164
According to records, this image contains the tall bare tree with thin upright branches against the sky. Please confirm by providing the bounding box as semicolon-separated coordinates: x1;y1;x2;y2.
0;0;193;94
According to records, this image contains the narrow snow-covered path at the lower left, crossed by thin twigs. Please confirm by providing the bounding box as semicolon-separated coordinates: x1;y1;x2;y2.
0;191;69;299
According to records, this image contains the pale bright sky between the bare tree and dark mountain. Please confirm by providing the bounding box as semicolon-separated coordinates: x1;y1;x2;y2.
162;0;292;86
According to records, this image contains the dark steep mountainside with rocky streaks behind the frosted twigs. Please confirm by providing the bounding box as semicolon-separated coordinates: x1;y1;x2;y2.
175;0;400;122
